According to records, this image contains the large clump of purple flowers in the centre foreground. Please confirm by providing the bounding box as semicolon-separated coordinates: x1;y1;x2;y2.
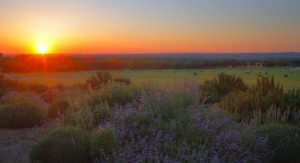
95;84;269;162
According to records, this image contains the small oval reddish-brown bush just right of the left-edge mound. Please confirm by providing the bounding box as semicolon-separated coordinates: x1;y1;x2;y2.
48;100;70;118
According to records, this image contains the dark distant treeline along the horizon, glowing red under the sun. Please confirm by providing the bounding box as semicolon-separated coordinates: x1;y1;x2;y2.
0;55;300;72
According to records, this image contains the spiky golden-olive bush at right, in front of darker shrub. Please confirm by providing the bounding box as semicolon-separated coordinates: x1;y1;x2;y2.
219;76;290;122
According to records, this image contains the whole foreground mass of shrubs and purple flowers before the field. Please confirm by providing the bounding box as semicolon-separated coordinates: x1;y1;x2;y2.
0;72;300;163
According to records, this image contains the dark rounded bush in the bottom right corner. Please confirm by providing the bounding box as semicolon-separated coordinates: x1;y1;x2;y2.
257;124;300;163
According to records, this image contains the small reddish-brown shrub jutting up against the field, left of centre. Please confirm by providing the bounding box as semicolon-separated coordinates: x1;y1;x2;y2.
86;71;112;89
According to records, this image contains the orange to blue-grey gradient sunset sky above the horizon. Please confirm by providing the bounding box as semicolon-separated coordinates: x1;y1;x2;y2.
0;0;300;53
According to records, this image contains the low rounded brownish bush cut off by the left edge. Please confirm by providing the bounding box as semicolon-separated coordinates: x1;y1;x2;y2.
0;101;46;128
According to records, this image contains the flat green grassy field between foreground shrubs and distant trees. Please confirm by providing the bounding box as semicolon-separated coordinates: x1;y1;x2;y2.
6;67;300;89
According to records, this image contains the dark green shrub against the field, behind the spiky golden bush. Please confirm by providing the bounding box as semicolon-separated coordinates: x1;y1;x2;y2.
203;73;248;102
